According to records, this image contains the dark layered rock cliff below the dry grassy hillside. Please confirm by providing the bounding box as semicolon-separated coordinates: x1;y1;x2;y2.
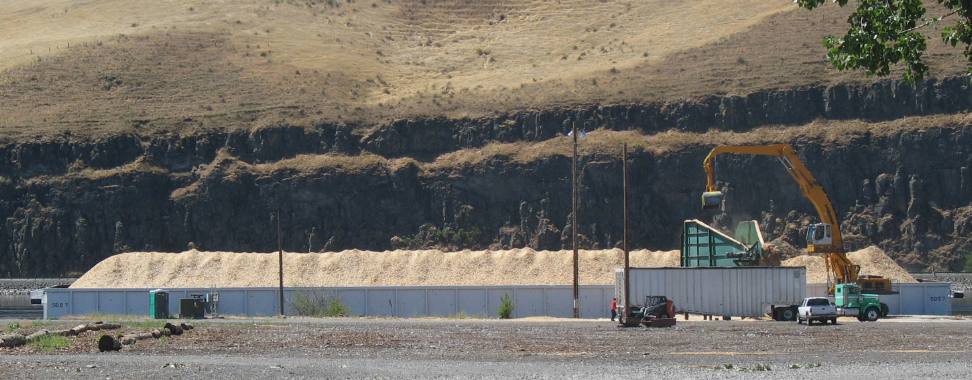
0;79;972;276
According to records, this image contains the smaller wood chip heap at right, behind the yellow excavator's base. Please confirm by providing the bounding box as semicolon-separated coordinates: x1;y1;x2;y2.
781;246;917;284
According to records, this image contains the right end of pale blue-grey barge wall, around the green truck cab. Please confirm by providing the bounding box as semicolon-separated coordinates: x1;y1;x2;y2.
807;282;953;315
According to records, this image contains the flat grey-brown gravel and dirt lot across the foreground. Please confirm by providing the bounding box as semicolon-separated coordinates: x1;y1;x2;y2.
0;319;972;379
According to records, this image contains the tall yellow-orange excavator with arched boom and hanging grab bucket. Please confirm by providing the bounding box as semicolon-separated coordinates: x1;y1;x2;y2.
702;144;892;294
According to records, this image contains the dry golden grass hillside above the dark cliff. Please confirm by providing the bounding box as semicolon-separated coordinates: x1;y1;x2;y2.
0;0;963;137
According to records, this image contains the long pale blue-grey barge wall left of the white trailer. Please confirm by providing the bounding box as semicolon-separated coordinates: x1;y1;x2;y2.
42;285;614;319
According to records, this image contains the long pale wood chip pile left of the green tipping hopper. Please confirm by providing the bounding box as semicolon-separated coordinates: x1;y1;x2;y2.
71;248;679;288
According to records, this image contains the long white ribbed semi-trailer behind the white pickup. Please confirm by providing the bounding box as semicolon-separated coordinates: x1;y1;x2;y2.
615;267;807;317
